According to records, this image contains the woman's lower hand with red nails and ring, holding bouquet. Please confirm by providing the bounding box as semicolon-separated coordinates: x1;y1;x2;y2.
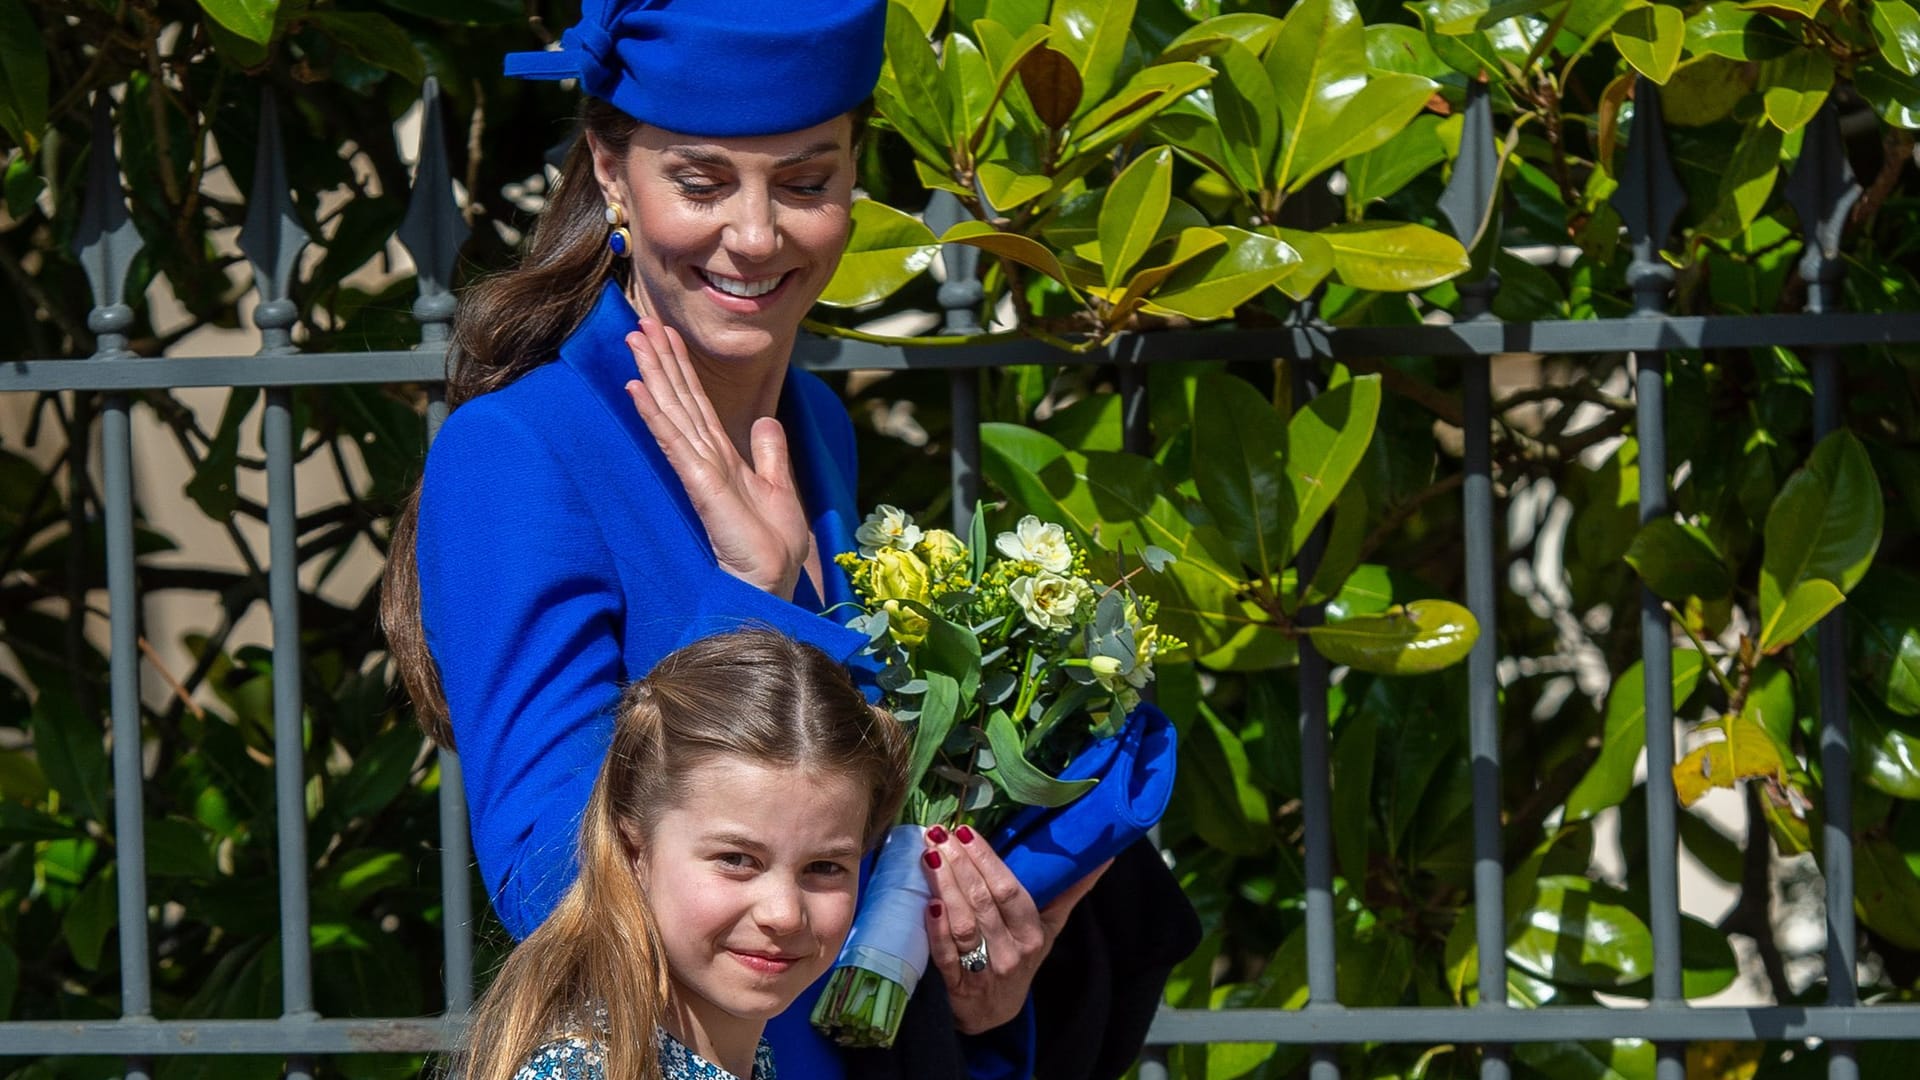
922;824;1112;1036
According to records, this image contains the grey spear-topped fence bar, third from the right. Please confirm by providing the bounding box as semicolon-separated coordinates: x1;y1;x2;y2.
1440;81;1511;1080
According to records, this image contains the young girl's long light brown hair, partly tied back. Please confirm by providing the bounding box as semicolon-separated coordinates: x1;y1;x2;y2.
451;630;908;1080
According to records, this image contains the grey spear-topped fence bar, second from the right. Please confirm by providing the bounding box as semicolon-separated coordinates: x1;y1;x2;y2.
1613;79;1686;1080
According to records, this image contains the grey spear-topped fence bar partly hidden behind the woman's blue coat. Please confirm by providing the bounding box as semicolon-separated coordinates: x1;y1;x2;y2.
396;77;474;1015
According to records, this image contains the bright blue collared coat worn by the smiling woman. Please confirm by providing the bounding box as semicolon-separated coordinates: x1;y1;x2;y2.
415;284;1033;1080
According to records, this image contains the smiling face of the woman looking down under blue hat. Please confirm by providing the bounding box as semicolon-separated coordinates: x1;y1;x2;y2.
593;115;854;365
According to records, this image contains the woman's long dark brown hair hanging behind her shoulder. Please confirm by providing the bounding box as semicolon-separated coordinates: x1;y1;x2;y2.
380;98;639;737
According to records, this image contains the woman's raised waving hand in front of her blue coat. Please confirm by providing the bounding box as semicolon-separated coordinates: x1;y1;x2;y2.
626;317;812;600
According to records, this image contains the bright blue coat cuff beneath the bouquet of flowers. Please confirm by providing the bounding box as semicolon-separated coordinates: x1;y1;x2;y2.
993;701;1179;907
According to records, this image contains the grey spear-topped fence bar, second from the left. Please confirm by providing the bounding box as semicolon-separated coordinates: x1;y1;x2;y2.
240;88;319;1080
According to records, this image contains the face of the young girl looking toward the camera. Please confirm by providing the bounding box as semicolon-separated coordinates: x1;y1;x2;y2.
634;757;872;1049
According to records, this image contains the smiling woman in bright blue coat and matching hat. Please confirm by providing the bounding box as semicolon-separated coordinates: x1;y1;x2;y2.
382;0;1190;1076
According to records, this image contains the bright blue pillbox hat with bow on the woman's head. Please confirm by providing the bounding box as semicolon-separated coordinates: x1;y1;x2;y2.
507;0;887;136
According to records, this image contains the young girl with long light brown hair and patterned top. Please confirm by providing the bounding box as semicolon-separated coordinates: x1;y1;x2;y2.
453;630;906;1080
